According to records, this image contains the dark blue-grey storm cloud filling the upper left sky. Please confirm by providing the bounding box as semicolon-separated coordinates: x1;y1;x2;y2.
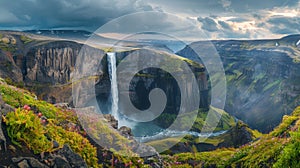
0;0;152;29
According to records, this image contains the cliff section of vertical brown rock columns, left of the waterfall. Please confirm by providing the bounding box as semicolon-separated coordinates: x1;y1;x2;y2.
22;41;81;84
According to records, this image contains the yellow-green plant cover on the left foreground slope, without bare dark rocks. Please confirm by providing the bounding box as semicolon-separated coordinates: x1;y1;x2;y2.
0;78;142;167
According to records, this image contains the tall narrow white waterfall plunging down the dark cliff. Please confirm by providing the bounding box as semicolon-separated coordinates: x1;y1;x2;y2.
107;52;119;121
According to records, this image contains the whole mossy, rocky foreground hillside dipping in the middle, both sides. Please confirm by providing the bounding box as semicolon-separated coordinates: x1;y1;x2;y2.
0;79;300;167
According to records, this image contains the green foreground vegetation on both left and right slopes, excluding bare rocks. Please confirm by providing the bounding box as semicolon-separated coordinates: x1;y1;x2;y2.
0;79;300;167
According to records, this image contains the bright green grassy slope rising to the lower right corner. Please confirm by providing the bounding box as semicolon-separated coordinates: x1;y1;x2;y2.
164;106;300;167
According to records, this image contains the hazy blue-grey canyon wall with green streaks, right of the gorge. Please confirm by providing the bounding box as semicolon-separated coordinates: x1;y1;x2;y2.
179;36;300;132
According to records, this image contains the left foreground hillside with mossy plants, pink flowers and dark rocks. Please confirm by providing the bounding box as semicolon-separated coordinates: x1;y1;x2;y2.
0;79;159;167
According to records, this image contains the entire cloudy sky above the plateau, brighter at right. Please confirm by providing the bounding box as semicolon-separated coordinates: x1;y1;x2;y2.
0;0;300;39
